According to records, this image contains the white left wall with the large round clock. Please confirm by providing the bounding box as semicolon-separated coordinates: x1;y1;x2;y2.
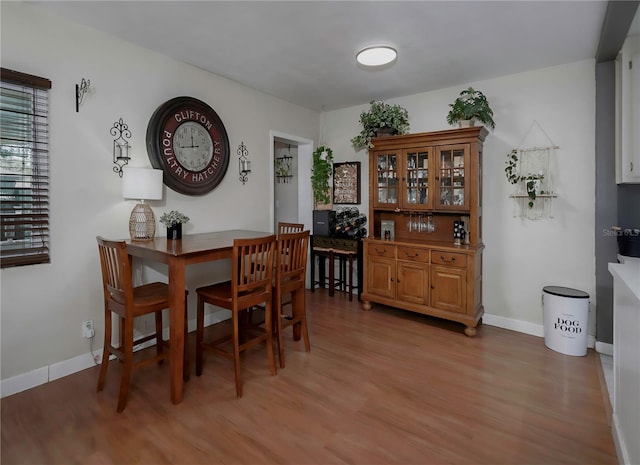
0;2;319;390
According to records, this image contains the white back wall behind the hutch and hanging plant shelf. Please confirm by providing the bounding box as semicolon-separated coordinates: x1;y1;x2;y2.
325;60;595;335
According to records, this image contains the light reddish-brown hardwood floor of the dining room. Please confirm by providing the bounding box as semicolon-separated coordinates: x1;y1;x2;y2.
1;290;618;465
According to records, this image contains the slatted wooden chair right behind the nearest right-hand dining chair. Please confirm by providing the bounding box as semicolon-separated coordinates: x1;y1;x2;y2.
273;230;311;368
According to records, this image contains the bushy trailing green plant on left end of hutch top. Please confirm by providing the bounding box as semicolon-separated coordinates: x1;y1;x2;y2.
351;100;409;150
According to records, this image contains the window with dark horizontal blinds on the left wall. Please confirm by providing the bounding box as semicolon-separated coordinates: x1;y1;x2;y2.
0;68;51;268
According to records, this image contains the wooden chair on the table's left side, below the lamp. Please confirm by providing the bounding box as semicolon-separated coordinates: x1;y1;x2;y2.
96;236;189;412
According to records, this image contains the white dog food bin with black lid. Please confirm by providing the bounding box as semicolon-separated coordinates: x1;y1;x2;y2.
542;286;589;356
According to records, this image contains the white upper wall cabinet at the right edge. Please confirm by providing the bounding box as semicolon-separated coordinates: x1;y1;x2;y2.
616;36;640;184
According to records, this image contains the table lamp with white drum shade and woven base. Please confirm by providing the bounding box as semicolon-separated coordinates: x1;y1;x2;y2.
122;166;162;241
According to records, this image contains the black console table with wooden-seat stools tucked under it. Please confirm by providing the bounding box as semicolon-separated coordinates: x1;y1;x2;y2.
311;235;362;300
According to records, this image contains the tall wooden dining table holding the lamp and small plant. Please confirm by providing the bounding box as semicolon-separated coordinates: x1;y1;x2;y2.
127;229;272;404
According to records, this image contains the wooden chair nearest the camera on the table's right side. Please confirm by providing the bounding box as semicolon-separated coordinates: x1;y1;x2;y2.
196;234;276;397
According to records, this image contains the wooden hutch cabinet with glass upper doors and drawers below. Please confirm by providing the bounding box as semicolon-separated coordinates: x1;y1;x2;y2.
362;127;488;336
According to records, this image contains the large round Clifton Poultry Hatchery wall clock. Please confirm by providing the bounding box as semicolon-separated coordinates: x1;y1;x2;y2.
147;97;229;195
